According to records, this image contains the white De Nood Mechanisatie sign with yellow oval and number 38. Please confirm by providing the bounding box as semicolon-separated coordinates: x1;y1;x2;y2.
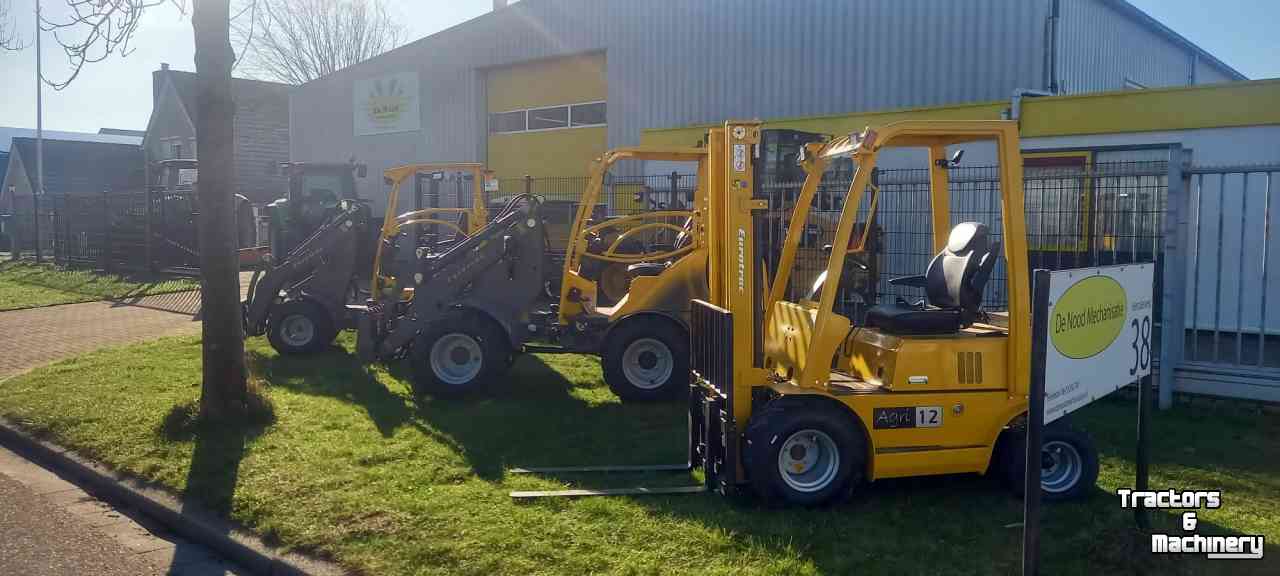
1037;264;1156;424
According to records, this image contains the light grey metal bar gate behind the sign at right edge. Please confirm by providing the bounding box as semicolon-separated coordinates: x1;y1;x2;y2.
1170;165;1280;402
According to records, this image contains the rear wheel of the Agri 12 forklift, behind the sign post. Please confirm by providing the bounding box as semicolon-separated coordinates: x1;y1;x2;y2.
998;422;1098;502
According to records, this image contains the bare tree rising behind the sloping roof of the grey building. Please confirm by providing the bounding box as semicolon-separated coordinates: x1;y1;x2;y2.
233;0;404;84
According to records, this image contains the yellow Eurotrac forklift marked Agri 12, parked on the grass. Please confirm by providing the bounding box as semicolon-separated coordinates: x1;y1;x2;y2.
690;120;1098;506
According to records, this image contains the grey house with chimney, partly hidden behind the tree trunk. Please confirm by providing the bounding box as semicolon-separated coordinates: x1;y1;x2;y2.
142;64;289;204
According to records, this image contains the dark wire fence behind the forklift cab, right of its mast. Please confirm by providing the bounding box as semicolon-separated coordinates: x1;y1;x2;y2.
763;161;1169;320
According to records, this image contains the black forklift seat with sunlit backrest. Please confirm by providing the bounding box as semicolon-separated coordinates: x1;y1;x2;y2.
867;221;1000;334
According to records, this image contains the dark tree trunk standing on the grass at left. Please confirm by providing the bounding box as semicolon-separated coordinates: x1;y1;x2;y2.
191;0;246;421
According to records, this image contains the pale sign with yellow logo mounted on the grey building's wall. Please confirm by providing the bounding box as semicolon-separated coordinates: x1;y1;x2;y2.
352;72;421;136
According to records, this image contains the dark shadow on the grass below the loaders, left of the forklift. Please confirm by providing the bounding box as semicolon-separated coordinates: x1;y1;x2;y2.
250;346;685;481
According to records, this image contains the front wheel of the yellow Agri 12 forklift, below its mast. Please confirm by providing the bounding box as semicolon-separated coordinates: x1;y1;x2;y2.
744;397;867;507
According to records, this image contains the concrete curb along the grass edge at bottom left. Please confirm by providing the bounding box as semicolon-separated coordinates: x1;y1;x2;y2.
0;417;351;576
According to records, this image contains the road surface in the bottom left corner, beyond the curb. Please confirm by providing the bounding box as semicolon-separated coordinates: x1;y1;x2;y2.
0;447;244;576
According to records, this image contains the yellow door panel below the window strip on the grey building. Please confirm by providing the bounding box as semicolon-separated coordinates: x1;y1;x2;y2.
488;125;608;178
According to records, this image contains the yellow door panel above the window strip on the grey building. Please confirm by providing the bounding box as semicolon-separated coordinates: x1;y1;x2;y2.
485;52;609;113
